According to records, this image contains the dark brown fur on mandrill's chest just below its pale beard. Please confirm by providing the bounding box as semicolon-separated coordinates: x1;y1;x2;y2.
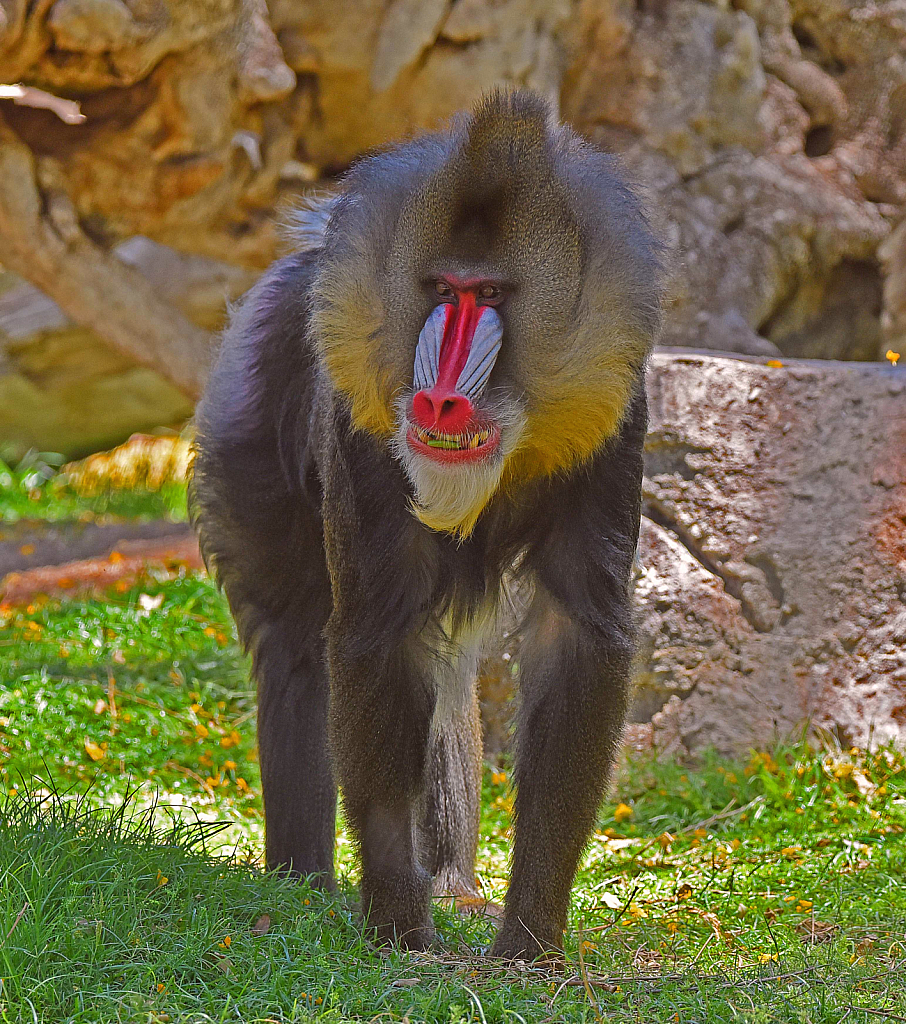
317;391;548;636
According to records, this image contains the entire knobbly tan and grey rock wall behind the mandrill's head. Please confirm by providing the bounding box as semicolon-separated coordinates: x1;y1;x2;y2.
0;0;906;462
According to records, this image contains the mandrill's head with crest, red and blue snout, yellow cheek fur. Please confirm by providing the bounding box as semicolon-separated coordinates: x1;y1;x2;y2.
301;92;660;530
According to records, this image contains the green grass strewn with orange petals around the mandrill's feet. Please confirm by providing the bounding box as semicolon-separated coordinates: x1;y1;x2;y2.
0;484;906;1024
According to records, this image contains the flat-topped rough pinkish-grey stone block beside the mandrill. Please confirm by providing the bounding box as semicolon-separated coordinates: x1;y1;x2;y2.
634;353;906;753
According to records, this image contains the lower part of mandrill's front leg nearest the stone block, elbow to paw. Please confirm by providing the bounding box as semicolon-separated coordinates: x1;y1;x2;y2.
491;591;632;959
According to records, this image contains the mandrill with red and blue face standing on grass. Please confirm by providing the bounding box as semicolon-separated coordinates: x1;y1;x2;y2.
192;92;660;958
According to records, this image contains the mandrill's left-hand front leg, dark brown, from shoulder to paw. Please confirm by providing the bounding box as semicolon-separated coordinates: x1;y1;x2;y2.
320;421;446;949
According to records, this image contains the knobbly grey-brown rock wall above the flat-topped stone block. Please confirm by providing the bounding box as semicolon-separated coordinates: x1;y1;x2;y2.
562;0;906;359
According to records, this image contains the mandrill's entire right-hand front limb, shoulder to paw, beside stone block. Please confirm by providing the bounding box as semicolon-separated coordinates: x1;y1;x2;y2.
492;384;646;958
